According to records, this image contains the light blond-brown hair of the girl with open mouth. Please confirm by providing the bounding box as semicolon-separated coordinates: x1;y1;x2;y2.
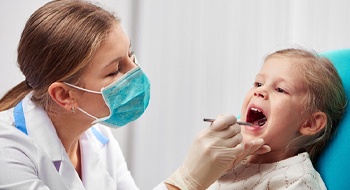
266;49;346;163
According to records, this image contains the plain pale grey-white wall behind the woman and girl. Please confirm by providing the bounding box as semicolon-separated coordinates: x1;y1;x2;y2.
0;0;350;189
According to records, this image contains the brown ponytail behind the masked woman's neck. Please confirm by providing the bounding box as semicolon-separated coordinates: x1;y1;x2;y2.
0;81;32;111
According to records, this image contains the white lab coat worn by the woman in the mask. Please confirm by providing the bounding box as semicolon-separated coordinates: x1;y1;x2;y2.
0;94;166;190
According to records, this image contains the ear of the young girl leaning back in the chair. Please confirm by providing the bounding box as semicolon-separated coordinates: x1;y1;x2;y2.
299;111;327;135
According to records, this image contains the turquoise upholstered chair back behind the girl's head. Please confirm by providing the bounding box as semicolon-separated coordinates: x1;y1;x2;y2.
316;49;350;190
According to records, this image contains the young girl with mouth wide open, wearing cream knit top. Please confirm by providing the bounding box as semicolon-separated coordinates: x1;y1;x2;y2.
209;49;346;190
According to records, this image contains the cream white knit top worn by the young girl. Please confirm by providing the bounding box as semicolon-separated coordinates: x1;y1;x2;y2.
209;152;327;190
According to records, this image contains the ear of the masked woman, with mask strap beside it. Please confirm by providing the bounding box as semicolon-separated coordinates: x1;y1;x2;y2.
48;82;76;112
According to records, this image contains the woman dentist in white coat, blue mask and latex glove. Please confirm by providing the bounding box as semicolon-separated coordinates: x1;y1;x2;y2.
0;0;268;190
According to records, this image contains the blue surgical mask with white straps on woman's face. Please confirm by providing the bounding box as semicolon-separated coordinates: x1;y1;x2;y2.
65;59;150;127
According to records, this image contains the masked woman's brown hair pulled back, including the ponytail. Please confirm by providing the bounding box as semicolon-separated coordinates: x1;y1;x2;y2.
0;0;119;110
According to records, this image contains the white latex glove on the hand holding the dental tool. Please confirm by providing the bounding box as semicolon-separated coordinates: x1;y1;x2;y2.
165;115;264;190
